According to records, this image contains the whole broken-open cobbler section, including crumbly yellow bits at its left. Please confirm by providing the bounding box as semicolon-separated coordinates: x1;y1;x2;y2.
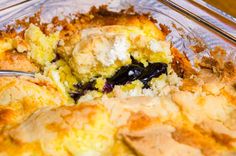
0;10;179;102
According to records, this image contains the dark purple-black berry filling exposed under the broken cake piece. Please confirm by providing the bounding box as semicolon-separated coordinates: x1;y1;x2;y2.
70;59;167;101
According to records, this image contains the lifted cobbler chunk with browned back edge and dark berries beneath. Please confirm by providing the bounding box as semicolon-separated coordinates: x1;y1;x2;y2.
53;12;179;100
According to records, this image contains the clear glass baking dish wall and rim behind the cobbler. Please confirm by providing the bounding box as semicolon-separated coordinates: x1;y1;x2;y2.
0;0;236;62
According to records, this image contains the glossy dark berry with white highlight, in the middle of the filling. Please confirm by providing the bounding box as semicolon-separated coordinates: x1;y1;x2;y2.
107;65;144;85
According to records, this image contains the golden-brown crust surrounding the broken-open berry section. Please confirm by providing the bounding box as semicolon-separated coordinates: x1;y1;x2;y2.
0;6;236;156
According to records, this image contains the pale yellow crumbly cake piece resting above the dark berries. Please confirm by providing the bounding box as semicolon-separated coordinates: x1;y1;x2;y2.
59;25;171;82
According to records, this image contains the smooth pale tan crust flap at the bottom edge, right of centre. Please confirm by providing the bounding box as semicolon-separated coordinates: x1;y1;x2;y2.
123;124;202;156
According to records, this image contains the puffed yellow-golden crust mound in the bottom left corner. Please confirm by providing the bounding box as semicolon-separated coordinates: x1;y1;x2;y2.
0;103;114;156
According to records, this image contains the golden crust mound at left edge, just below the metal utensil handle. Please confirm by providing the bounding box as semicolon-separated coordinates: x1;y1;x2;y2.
0;77;66;129
